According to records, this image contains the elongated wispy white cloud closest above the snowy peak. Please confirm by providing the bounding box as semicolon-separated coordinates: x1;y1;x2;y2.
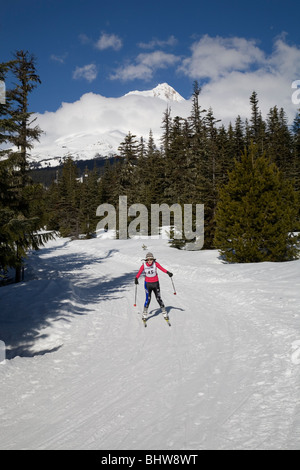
110;51;180;81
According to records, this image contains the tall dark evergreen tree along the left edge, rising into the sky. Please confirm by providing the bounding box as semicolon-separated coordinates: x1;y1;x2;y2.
0;51;51;282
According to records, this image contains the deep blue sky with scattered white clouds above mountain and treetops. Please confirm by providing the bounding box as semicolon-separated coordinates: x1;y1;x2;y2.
0;0;300;119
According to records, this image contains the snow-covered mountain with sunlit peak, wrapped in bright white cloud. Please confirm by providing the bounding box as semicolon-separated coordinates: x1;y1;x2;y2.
30;83;190;167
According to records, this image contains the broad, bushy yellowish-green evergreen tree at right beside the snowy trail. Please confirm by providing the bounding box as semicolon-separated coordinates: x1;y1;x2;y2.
215;145;298;263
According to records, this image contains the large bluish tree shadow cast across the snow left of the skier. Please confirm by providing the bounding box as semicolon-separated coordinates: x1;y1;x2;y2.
0;249;136;359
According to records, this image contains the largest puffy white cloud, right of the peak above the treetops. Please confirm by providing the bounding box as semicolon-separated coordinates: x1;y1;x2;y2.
178;35;300;124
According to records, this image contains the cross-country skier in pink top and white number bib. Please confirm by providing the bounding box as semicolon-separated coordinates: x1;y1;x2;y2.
135;253;173;320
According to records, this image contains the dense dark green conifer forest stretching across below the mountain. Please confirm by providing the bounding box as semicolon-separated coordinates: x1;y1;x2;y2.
0;51;300;281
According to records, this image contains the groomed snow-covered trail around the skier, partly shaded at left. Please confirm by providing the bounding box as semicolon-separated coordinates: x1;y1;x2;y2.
0;239;300;450
